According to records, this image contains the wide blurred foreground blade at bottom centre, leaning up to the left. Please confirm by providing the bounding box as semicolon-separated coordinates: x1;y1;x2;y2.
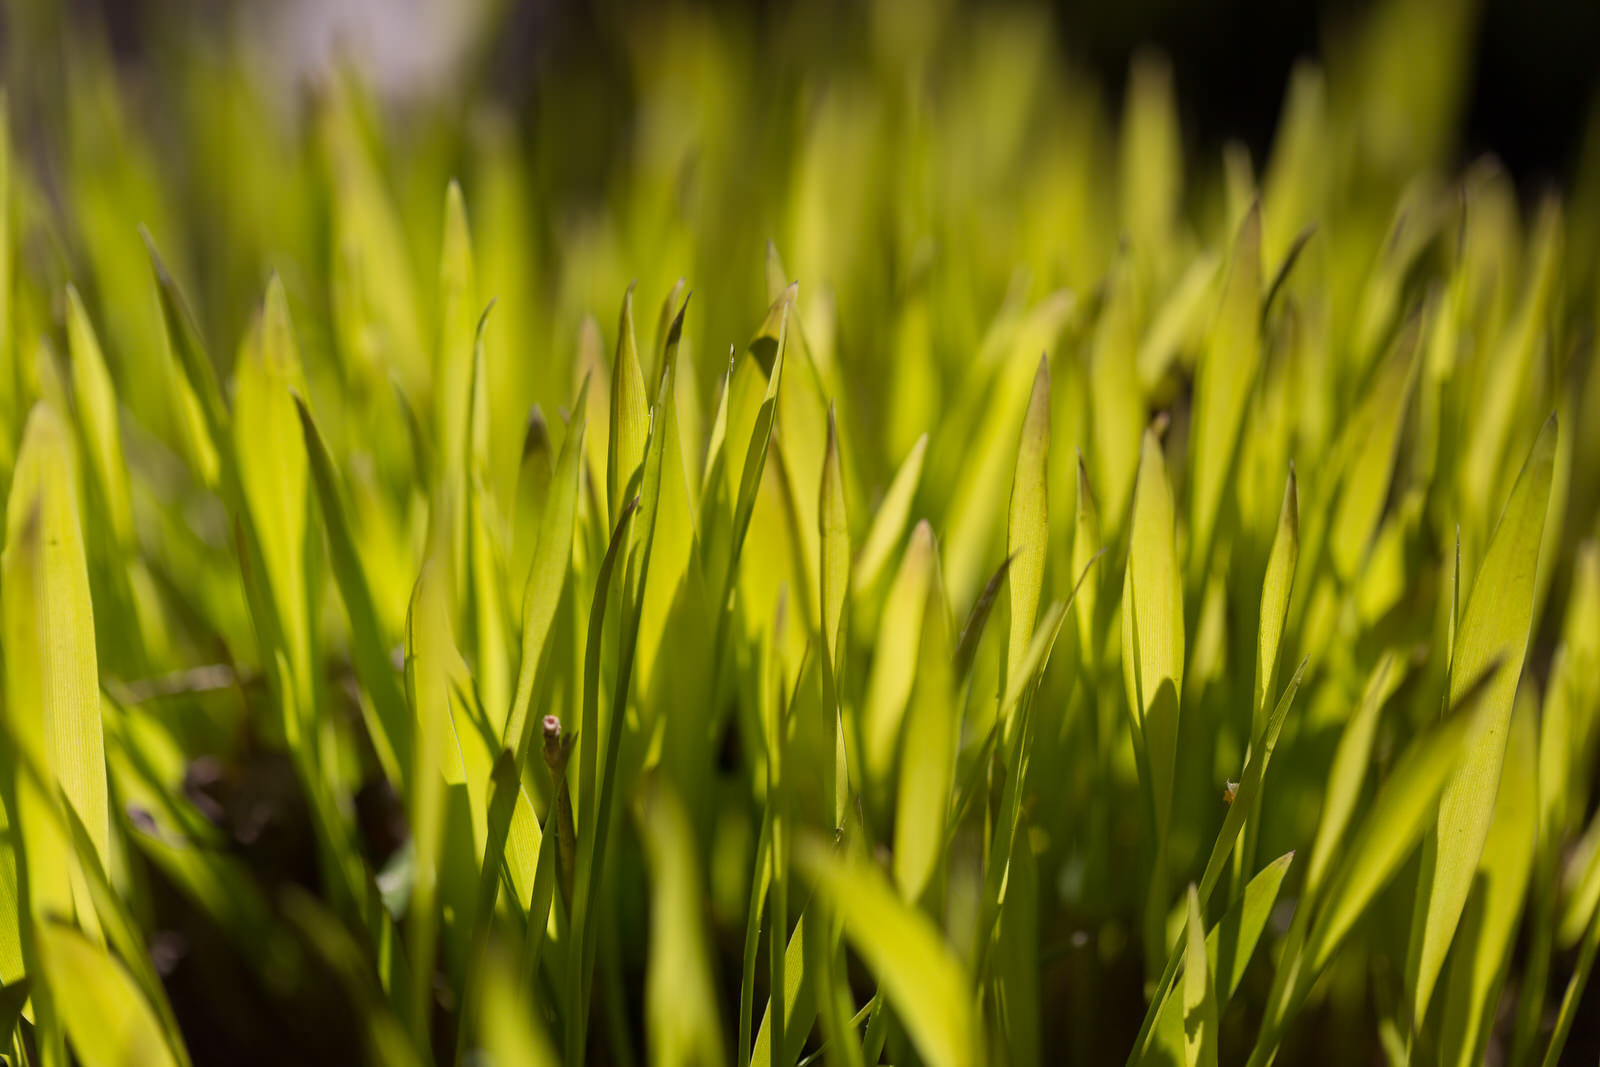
794;837;982;1067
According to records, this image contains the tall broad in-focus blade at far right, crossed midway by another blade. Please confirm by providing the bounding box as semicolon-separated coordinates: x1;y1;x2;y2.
1406;416;1557;1017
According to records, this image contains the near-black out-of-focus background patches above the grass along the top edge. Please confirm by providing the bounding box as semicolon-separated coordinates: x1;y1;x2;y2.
46;0;1600;190
